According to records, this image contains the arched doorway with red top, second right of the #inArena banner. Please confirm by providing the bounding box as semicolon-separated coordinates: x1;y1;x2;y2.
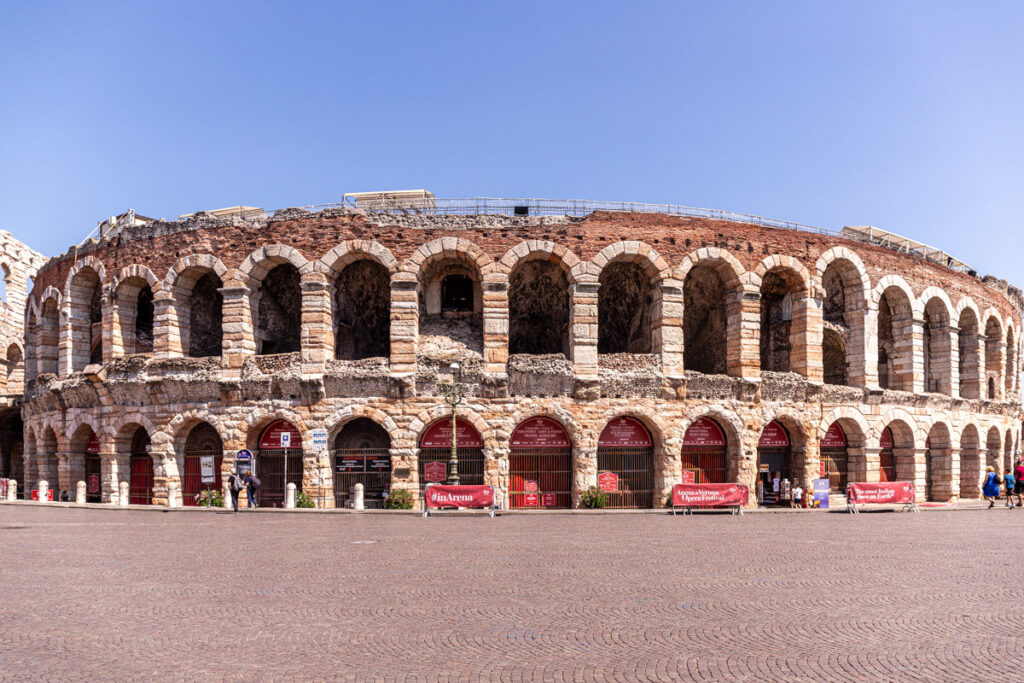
597;418;654;508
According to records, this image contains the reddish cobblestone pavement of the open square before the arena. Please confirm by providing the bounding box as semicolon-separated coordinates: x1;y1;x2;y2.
0;506;1024;681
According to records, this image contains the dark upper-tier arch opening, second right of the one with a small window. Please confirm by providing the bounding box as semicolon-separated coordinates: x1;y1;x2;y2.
597;261;654;353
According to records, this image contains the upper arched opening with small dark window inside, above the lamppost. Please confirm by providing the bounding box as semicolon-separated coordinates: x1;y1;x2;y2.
418;255;483;358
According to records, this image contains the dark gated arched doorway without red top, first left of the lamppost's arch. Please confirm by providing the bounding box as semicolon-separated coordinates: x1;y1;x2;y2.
332;418;391;509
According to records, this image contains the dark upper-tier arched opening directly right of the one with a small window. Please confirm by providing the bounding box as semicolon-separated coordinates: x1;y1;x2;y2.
509;259;569;358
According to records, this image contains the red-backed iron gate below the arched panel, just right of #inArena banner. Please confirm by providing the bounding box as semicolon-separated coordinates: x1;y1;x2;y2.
509;449;572;509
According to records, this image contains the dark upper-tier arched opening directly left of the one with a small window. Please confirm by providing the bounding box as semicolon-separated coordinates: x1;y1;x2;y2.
334;259;391;360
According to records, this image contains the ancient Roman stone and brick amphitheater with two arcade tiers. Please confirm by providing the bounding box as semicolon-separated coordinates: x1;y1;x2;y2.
0;200;1024;509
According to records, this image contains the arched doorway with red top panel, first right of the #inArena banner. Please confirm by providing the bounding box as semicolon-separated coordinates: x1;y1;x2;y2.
509;418;572;509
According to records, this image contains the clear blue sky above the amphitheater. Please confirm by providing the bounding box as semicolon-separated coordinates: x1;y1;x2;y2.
0;0;1024;286
